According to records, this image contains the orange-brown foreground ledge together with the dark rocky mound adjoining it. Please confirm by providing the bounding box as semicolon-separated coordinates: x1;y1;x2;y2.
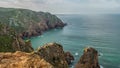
0;43;74;68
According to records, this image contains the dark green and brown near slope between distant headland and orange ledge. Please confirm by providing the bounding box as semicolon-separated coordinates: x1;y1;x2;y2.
0;23;33;52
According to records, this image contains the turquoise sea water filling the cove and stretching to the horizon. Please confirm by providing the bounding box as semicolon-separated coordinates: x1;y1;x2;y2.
31;14;120;68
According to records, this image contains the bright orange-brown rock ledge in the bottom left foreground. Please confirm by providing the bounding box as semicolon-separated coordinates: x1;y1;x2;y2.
0;51;55;68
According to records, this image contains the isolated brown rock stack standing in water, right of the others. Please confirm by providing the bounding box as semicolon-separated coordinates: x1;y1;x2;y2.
75;47;100;68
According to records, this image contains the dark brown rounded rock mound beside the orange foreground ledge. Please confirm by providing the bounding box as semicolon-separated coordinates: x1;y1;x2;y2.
35;43;68;68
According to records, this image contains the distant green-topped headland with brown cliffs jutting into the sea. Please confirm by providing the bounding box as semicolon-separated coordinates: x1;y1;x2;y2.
0;8;66;37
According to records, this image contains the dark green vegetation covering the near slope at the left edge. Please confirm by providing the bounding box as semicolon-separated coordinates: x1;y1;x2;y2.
0;23;14;52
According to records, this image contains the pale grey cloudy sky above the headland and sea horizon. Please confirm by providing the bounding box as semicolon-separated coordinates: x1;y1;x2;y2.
0;0;120;14
